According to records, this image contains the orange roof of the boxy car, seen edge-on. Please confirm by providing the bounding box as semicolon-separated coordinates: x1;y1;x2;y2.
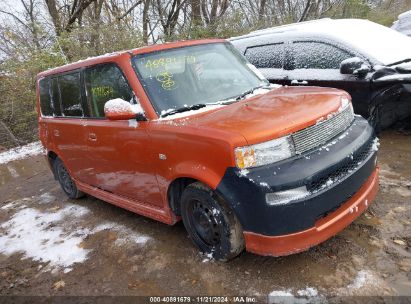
37;39;227;78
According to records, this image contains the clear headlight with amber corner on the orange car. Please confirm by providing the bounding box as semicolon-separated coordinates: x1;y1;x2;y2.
234;136;295;169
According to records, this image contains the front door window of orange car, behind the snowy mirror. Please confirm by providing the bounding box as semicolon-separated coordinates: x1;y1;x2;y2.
84;64;133;118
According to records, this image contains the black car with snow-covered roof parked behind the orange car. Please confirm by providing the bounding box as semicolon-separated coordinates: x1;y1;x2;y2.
230;19;411;128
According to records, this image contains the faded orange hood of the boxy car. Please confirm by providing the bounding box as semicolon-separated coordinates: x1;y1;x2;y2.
169;87;351;144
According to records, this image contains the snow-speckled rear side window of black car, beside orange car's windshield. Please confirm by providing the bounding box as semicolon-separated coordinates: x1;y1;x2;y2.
245;43;285;69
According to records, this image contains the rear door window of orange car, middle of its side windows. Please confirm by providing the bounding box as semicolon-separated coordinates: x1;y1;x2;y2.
58;72;83;117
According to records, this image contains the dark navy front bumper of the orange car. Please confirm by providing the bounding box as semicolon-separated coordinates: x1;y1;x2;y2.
216;117;377;254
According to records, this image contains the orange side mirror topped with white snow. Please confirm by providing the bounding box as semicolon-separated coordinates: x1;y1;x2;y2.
104;98;145;120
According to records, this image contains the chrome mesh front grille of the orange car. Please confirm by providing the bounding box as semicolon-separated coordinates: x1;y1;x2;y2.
291;105;354;154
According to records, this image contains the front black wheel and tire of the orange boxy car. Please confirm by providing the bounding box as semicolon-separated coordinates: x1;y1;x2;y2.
181;182;245;261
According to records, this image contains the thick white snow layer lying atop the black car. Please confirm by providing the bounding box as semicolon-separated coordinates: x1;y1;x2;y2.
230;18;411;65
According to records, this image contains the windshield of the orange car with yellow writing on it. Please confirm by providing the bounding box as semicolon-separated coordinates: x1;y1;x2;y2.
133;43;268;115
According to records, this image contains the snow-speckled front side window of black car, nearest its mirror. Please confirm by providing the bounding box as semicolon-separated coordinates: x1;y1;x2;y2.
293;41;353;69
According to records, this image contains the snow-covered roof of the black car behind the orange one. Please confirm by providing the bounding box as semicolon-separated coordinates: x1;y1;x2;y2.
229;19;411;65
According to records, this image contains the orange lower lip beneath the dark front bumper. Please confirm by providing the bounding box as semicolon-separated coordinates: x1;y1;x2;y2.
244;168;378;256
